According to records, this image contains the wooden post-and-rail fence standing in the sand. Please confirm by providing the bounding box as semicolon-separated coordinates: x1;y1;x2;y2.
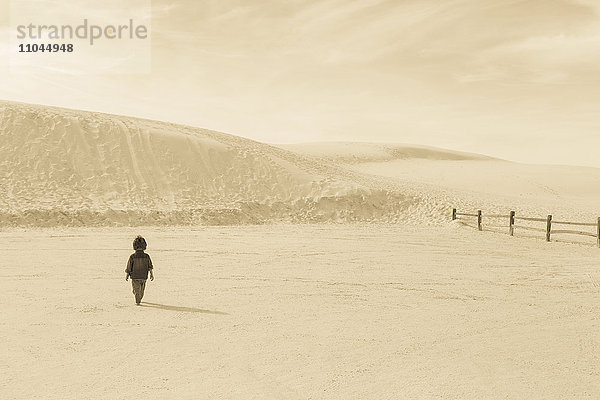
452;208;600;247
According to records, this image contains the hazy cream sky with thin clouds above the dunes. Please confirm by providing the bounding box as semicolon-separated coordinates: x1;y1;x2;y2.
0;0;600;167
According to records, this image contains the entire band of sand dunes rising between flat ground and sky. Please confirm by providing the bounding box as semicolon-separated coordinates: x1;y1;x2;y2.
0;102;600;226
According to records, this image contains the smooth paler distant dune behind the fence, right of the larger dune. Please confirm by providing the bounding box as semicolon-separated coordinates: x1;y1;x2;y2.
282;143;600;224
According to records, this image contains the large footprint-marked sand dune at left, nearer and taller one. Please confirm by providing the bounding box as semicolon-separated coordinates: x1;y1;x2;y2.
0;102;454;226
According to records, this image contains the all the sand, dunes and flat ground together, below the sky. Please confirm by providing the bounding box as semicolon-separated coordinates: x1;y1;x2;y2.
0;102;600;399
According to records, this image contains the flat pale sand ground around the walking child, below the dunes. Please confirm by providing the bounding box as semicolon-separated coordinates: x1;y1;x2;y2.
0;224;600;399
